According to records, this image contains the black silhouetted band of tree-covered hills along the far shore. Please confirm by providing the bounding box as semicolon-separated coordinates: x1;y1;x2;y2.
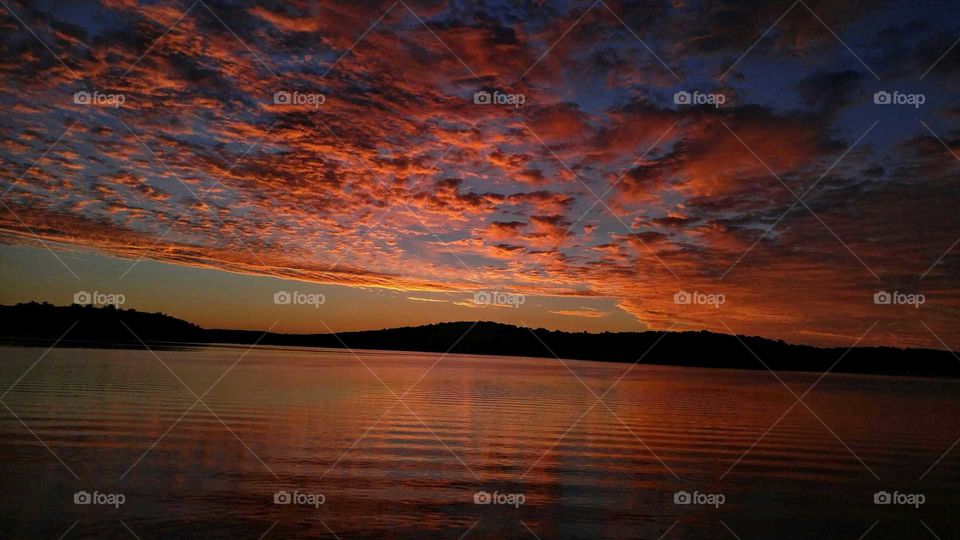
0;302;960;377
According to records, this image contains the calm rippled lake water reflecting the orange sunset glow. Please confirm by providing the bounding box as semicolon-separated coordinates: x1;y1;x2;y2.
0;347;960;540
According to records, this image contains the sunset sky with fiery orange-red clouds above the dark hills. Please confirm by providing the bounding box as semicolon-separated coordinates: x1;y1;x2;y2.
0;0;960;349
